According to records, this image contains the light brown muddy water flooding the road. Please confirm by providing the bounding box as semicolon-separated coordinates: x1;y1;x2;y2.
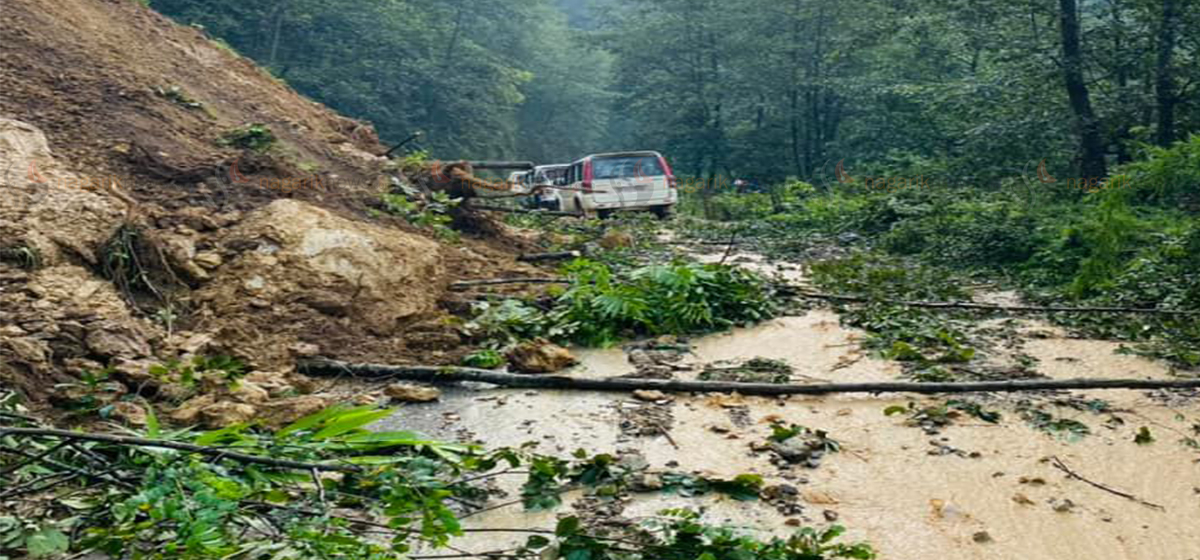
381;286;1200;560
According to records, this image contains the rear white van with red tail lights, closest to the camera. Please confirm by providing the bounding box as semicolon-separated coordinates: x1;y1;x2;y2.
558;151;679;217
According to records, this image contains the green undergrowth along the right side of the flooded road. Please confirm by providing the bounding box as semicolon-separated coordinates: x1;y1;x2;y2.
682;137;1200;377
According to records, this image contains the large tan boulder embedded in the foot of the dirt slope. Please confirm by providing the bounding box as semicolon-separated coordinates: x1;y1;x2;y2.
193;199;444;367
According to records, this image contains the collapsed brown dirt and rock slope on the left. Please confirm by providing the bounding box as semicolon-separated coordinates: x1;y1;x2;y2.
0;0;528;423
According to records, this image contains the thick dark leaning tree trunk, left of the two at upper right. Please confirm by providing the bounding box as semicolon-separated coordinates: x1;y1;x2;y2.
1058;0;1108;179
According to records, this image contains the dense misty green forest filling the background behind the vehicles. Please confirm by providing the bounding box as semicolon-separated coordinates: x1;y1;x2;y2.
152;0;1200;186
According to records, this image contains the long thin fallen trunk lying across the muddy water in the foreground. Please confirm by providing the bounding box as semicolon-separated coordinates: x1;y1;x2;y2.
299;360;1200;396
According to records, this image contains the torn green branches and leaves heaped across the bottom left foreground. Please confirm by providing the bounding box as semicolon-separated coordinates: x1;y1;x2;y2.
0;407;875;560
